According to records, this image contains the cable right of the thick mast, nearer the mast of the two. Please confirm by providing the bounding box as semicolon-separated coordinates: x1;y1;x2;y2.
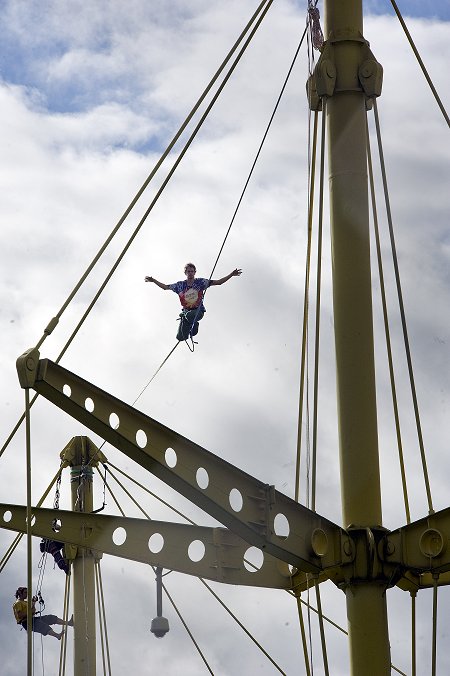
366;116;411;523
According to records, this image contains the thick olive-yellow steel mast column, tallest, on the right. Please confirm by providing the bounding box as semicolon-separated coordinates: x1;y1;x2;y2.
325;0;390;676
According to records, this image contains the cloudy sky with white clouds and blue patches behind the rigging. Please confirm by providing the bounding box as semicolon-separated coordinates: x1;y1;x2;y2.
0;0;450;676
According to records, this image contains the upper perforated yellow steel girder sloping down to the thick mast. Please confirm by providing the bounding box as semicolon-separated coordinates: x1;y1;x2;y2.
17;350;350;573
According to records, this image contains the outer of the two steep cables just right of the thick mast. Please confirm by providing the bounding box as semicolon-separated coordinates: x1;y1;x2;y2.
373;98;434;514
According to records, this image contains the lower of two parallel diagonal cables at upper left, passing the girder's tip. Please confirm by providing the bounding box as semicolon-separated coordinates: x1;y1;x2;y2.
0;0;273;464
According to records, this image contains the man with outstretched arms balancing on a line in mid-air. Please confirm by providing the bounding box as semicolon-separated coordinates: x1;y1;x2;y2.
145;263;242;340
